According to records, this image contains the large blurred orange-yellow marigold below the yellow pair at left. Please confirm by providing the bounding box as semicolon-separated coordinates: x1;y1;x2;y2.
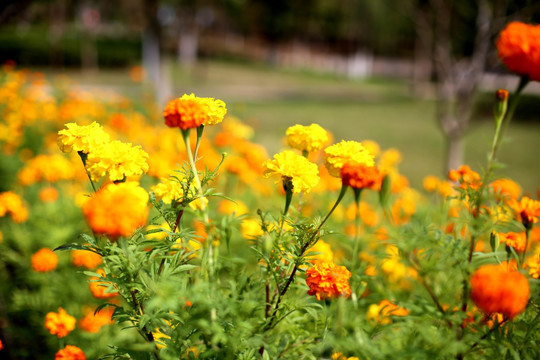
82;182;148;239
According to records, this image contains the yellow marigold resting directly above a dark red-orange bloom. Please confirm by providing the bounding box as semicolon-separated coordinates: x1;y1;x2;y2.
324;140;375;177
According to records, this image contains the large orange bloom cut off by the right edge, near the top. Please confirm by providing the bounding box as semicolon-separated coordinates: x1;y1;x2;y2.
497;21;540;81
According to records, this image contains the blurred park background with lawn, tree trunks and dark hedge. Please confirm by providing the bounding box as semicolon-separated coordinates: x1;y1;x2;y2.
0;0;540;195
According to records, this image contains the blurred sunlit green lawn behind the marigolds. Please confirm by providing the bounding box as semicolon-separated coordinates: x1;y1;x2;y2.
39;61;540;195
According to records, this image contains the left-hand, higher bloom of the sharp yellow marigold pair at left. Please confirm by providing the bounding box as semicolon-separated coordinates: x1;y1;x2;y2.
57;122;110;154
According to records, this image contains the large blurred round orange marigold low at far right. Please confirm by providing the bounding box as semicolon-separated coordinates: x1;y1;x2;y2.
471;264;530;319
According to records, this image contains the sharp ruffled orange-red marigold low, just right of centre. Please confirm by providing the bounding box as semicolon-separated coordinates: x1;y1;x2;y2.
306;260;352;300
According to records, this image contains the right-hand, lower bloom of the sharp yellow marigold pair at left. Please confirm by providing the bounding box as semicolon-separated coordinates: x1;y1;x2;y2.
86;140;148;181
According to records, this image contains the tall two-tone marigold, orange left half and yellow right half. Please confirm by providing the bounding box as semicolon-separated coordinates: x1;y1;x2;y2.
163;94;227;130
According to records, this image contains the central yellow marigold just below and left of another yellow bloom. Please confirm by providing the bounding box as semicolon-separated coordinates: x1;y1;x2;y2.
263;151;319;194
